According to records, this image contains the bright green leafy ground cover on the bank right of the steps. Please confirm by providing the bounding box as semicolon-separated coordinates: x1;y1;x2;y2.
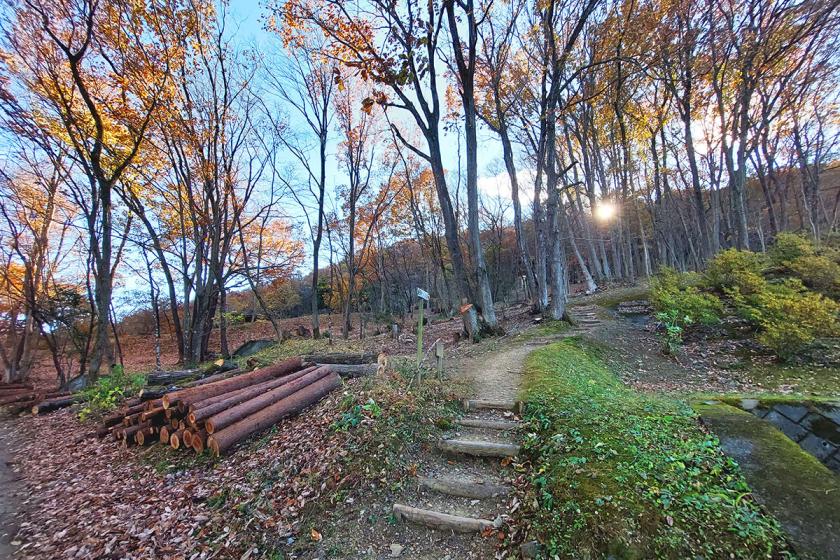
521;339;792;559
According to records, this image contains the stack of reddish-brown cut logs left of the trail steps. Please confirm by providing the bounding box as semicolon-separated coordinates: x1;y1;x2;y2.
92;358;341;456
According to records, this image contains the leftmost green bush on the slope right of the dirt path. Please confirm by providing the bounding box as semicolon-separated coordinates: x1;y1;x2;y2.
650;267;723;328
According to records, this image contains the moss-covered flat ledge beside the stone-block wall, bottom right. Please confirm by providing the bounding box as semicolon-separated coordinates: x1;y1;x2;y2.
694;403;840;559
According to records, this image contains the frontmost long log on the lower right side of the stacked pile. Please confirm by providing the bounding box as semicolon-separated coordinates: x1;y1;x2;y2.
207;370;341;457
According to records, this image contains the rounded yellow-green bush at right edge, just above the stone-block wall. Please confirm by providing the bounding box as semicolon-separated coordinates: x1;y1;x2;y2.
734;278;840;361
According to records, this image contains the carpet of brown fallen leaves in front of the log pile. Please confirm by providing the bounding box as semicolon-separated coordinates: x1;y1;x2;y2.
4;381;354;560
